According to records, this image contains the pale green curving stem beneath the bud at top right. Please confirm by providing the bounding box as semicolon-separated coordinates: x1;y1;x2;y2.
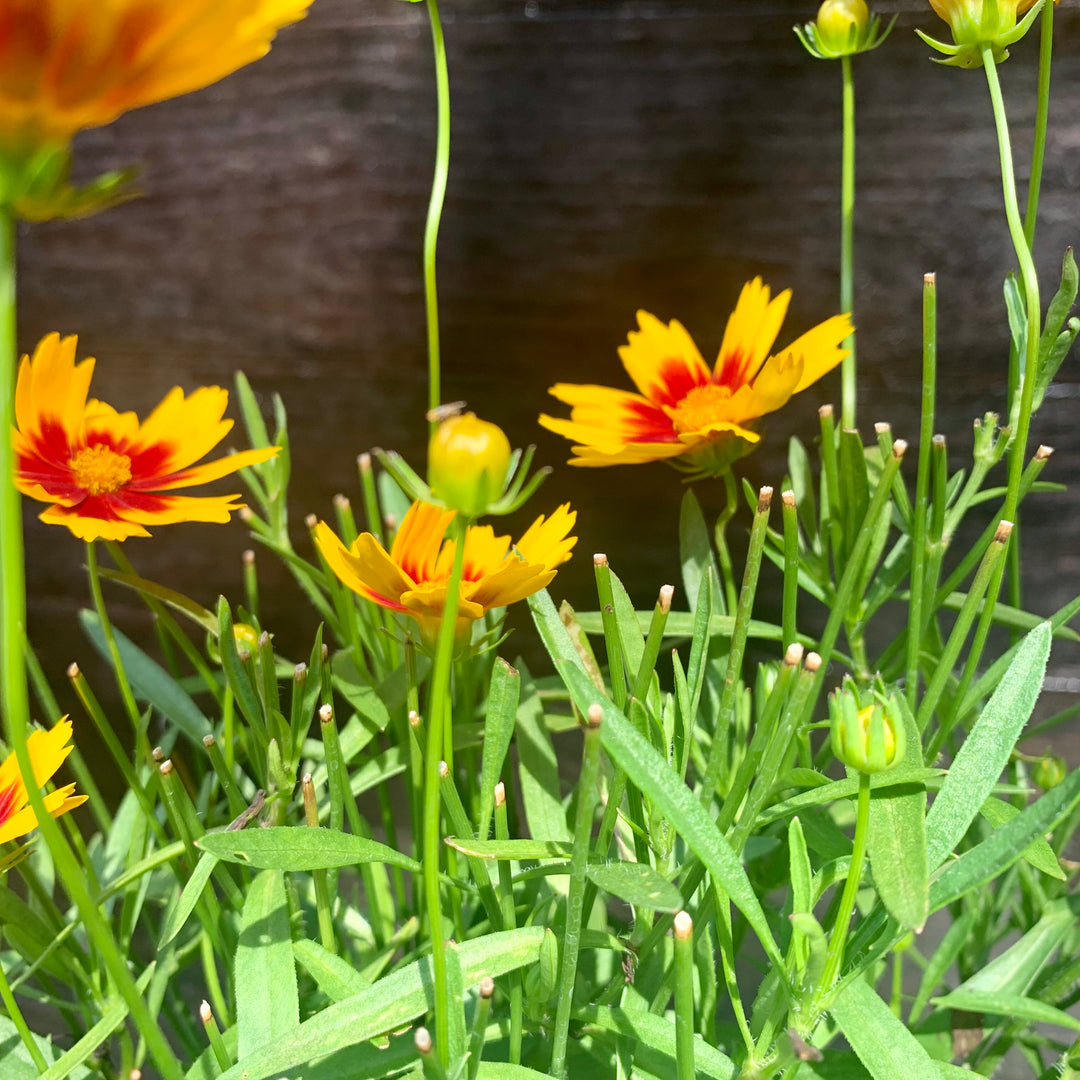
983;45;1042;527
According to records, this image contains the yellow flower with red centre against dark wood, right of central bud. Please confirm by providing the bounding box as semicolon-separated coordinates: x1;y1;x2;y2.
540;278;852;475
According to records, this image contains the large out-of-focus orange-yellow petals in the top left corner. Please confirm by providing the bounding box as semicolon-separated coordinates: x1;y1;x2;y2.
0;0;311;149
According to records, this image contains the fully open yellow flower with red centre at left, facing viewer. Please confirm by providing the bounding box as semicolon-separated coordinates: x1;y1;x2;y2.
13;334;279;541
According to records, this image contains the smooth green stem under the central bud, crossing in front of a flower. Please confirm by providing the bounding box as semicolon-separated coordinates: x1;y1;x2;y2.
422;514;468;1065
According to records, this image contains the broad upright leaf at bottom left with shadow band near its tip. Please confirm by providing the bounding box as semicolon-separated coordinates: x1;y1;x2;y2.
234;870;300;1059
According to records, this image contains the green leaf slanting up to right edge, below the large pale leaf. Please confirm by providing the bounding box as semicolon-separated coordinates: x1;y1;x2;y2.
930;769;1080;912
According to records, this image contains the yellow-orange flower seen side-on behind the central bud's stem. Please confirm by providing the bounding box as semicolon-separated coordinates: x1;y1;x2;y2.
315;502;578;644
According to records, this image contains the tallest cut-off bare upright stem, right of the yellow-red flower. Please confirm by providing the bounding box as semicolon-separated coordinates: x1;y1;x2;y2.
904;273;937;710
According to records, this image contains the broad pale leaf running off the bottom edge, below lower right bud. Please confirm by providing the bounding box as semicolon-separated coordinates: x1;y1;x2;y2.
832;978;941;1080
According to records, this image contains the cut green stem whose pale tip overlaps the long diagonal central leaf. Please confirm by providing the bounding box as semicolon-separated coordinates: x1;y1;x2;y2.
550;705;603;1077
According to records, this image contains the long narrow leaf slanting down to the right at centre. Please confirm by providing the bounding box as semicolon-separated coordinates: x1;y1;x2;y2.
556;663;783;967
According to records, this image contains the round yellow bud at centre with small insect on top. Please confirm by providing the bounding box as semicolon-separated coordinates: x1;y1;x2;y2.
428;413;510;517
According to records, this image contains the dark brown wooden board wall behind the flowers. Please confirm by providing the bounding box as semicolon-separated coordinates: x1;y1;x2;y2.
19;0;1080;777
